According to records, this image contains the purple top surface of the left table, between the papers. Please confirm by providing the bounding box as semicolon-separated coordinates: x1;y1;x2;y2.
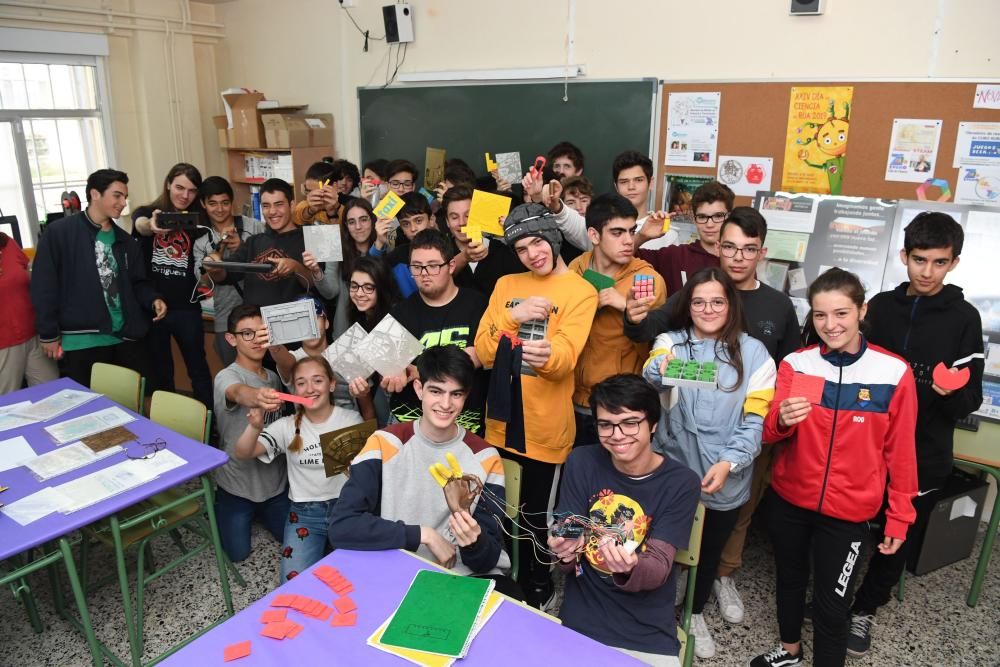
0;378;227;560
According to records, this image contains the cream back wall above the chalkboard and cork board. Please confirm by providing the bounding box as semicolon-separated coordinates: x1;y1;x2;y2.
217;0;1000;159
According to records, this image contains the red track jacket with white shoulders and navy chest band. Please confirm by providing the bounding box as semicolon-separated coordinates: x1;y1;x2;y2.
763;338;917;539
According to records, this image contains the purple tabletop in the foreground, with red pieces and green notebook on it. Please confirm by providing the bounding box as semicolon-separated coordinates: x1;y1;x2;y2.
161;550;640;667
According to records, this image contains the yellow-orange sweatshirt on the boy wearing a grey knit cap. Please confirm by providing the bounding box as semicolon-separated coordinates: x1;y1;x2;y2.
476;271;597;463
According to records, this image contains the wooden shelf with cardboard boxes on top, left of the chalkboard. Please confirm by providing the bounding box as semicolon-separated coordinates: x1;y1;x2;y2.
213;91;335;211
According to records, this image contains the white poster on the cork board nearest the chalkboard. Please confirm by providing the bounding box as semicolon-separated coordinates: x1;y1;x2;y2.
666;93;722;167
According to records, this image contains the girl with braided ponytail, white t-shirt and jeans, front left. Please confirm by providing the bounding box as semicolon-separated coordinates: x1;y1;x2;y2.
234;357;363;581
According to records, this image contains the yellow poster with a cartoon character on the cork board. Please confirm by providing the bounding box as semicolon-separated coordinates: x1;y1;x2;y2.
781;86;854;195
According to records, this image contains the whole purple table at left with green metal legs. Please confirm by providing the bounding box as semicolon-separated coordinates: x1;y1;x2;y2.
0;378;233;665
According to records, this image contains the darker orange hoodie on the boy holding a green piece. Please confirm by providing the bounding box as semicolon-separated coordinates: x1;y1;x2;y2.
569;252;667;407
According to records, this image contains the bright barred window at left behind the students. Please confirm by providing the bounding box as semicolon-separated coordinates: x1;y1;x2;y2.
0;52;110;246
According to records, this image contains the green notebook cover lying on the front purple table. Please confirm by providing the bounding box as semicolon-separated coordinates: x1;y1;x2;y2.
382;570;494;658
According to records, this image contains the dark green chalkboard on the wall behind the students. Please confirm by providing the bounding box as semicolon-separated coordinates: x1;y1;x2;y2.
358;79;657;193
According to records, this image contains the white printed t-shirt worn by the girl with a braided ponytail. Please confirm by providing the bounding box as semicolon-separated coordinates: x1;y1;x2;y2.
257;407;364;503
